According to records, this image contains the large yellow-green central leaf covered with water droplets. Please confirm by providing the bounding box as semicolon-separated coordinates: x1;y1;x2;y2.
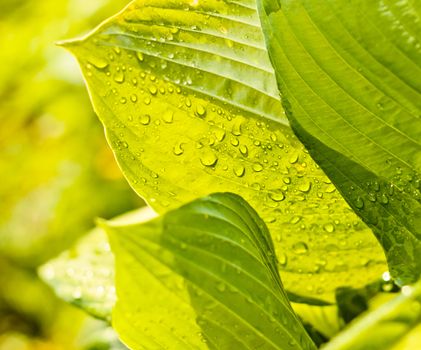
65;0;386;301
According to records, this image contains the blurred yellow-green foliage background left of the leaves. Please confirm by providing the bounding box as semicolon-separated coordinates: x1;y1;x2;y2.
0;0;143;350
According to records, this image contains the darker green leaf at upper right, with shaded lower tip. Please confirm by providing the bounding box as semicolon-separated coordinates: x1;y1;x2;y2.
259;0;421;285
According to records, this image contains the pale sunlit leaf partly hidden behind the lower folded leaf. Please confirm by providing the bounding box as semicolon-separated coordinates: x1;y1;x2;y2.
39;208;156;321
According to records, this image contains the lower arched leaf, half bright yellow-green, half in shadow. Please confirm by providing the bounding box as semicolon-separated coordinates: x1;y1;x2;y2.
103;193;315;350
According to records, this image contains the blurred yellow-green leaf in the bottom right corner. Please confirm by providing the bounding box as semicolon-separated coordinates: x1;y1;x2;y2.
323;282;421;350
